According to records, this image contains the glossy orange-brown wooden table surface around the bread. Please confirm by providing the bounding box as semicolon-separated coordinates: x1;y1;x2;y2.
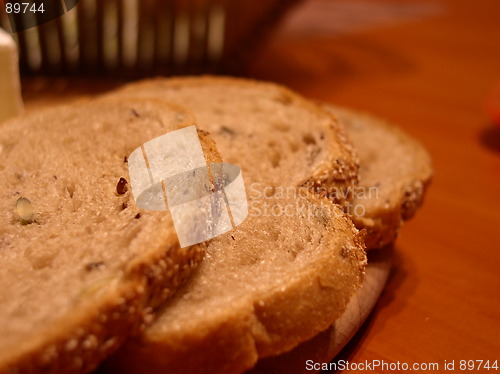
20;0;500;373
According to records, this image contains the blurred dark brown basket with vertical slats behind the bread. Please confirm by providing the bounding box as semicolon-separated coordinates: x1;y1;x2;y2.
0;0;298;76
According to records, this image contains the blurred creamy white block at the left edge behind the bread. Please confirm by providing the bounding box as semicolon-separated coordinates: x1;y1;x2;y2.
0;28;23;122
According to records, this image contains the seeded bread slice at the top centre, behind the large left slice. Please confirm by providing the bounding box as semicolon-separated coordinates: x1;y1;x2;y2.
113;76;358;203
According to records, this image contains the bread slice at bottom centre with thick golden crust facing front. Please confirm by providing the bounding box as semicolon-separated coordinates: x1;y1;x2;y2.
106;189;366;374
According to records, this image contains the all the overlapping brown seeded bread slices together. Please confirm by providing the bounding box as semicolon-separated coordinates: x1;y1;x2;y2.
0;77;432;373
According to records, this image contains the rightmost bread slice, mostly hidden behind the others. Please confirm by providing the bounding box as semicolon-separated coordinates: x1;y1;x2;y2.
325;105;433;249
